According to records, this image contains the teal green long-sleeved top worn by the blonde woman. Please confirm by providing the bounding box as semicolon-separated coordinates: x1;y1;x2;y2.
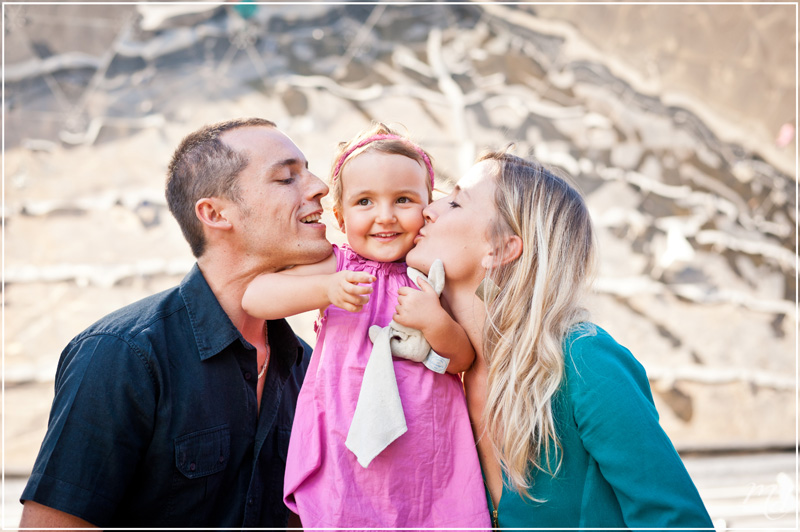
489;324;713;529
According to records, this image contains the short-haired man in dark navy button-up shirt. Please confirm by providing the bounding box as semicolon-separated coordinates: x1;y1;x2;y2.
20;119;331;528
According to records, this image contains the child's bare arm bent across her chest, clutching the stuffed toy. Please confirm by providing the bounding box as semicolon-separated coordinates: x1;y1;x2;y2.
394;281;475;373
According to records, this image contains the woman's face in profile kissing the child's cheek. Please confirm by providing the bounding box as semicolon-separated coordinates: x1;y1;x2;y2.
406;161;496;287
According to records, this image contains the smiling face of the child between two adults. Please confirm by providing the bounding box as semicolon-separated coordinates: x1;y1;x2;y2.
335;151;429;262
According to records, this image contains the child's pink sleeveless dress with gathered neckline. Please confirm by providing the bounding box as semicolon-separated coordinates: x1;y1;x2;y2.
284;245;491;529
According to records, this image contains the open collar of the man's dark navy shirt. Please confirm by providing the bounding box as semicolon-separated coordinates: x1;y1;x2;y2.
179;263;303;364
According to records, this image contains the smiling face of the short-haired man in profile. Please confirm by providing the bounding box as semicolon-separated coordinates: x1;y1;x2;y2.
221;127;331;270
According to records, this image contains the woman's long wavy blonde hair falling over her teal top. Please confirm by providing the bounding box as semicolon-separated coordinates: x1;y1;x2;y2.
479;152;595;498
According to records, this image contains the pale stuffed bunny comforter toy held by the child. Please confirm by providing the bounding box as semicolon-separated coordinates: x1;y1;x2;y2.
345;259;450;467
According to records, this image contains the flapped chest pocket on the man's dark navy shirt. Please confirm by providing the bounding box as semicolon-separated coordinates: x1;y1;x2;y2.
175;425;231;479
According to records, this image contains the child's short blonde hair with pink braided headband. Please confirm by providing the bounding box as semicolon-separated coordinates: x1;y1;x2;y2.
330;122;434;220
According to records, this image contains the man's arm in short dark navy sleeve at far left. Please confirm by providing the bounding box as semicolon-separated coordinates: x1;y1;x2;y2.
20;331;157;527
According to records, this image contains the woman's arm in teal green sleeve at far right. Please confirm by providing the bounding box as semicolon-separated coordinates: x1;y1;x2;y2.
565;327;713;529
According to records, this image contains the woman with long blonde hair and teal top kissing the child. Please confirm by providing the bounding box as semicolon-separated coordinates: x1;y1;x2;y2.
407;153;712;528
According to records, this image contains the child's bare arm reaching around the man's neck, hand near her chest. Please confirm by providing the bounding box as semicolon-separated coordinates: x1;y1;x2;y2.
242;251;375;320
